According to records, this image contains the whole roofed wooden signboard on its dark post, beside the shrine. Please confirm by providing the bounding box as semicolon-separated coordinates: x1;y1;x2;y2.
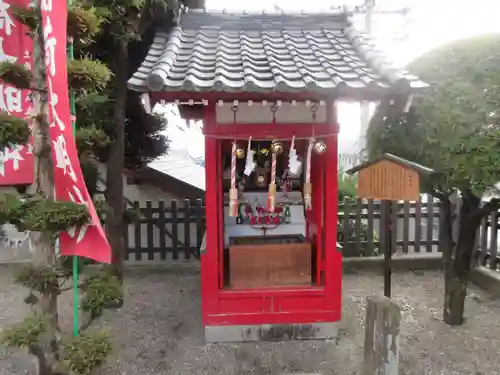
346;154;434;298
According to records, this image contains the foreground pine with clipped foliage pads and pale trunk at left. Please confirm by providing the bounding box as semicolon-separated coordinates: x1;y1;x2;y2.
0;0;123;375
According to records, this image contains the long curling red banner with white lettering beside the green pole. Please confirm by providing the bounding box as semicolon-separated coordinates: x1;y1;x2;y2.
41;0;111;263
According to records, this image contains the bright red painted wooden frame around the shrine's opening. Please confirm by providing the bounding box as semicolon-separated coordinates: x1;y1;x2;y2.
201;98;342;326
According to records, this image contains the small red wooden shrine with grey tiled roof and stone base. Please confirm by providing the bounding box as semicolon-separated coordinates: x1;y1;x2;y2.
129;9;425;342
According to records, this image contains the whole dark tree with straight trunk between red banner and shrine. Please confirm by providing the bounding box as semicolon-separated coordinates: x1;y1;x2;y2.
79;0;182;279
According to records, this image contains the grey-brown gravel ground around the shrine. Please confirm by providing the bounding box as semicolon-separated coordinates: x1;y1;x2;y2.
0;267;500;375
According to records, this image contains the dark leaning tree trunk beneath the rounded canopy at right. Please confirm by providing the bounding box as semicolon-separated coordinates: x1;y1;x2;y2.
443;196;481;326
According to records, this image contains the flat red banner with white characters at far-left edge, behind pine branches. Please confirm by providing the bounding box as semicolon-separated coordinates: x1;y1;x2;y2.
0;0;34;185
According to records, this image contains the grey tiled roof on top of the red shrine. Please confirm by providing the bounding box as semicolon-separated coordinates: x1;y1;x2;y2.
129;11;427;97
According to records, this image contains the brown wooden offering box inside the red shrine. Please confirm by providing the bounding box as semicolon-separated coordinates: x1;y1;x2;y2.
229;235;311;288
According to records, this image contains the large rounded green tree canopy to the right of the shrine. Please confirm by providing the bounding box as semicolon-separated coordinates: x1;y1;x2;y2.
368;34;500;196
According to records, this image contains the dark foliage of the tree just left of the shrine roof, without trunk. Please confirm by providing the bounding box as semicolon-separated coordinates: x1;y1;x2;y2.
76;0;173;168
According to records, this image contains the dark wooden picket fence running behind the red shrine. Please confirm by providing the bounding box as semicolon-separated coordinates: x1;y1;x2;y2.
124;197;500;269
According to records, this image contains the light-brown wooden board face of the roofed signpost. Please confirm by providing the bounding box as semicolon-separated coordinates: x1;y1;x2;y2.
358;160;420;201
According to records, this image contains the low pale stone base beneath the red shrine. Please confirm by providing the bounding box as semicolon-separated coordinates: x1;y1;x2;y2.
205;322;339;343
